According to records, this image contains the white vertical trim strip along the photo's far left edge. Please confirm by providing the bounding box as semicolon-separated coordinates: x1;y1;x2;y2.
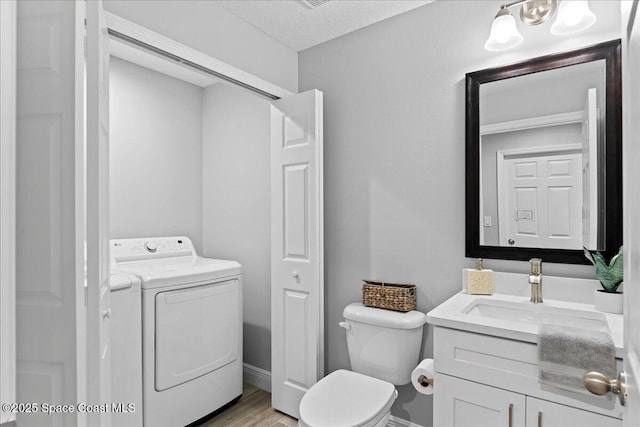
0;0;17;424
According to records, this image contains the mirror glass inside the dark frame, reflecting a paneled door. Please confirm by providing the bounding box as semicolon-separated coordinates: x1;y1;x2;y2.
479;61;606;254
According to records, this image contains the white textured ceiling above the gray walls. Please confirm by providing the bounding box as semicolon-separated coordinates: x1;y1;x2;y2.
216;0;434;52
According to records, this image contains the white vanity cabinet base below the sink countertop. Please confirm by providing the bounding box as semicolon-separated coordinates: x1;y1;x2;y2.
433;326;622;427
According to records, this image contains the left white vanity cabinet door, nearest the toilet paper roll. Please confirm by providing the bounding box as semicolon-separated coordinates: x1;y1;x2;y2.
433;374;525;427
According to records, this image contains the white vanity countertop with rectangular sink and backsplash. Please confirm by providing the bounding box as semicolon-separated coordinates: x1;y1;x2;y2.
427;272;624;357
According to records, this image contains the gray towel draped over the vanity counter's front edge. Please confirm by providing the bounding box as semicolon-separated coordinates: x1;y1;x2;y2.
538;324;616;394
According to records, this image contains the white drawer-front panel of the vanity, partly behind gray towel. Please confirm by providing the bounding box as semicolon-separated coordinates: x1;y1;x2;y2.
433;327;622;418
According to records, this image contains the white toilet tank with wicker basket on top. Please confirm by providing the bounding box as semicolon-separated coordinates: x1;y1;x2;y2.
340;303;427;385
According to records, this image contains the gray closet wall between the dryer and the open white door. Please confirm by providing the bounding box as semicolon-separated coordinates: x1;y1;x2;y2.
202;83;271;371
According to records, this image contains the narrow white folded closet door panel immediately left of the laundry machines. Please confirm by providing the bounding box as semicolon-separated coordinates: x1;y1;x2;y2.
86;0;111;426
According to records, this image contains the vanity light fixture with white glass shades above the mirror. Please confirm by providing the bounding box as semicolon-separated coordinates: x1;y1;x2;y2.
484;0;596;52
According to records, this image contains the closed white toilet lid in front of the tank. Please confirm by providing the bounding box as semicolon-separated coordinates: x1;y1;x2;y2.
300;369;396;427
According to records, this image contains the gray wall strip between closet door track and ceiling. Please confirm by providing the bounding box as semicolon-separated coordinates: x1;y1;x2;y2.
104;0;298;92
